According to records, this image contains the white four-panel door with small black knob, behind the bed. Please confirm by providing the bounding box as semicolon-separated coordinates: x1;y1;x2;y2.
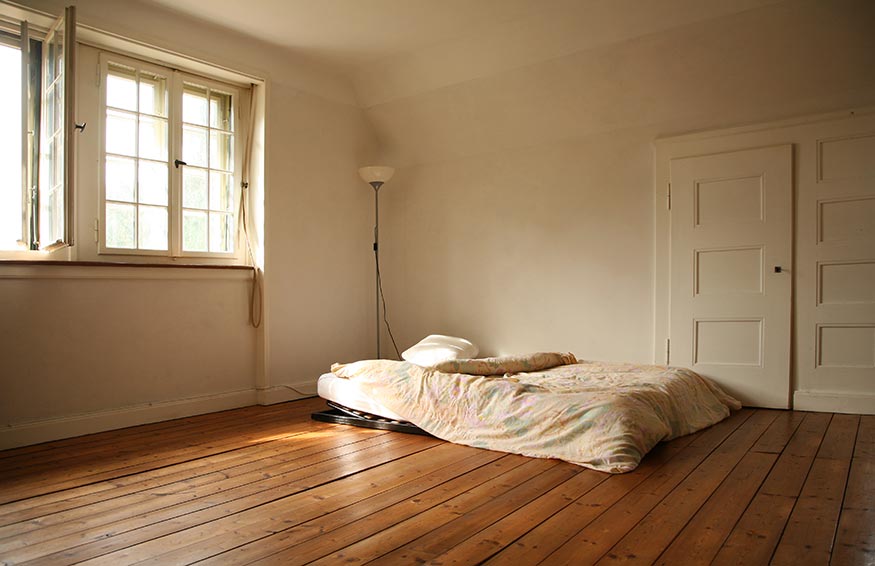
669;145;793;408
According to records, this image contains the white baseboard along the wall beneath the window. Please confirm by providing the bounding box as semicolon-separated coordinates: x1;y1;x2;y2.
0;389;258;450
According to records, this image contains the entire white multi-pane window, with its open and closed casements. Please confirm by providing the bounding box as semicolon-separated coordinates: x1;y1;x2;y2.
0;1;264;265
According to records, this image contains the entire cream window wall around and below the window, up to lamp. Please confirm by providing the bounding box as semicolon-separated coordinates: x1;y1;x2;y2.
0;0;376;446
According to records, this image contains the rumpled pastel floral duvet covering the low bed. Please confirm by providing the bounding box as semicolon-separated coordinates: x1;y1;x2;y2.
331;353;741;473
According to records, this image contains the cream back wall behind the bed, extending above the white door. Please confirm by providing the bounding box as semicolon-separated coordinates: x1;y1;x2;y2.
356;0;875;361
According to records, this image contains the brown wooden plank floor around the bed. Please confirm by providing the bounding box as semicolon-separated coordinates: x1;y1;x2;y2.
0;399;875;566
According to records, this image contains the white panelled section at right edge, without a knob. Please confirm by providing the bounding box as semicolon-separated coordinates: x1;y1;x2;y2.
794;121;875;414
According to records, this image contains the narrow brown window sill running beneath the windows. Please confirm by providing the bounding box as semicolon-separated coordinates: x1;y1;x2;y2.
0;260;252;280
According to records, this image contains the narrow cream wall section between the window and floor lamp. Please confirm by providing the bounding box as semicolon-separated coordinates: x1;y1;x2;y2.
265;86;376;393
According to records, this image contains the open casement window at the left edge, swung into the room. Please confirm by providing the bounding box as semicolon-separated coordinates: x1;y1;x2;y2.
0;7;76;251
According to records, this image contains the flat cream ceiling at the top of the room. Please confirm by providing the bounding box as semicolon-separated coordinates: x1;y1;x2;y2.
140;0;552;72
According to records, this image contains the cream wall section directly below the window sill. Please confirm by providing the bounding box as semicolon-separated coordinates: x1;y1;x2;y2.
0;266;255;422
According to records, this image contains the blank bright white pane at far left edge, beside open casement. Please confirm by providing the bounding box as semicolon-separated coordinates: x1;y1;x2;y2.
0;45;24;250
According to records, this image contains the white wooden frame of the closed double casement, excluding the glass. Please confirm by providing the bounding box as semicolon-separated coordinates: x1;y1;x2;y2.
97;50;249;263
